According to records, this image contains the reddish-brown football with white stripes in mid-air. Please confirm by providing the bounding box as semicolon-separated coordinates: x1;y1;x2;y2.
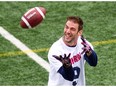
20;7;46;29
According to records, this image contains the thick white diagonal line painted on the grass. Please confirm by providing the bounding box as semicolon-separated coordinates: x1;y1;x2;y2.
0;27;50;72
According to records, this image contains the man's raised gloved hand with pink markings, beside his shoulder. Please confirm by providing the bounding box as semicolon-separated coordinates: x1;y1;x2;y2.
81;36;92;56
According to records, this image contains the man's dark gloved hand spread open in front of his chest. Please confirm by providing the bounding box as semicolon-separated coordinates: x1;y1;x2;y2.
53;53;71;68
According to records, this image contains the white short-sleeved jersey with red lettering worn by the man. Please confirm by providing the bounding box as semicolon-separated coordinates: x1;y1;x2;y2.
48;37;93;86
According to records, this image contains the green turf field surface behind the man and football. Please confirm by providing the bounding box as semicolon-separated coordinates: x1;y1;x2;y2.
0;1;116;86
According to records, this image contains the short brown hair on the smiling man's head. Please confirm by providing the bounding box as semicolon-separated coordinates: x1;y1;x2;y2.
67;16;83;31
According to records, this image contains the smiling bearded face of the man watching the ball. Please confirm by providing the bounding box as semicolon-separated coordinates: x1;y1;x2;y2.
63;21;79;46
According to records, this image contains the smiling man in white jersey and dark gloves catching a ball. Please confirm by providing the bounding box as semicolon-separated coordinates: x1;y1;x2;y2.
48;16;98;86
